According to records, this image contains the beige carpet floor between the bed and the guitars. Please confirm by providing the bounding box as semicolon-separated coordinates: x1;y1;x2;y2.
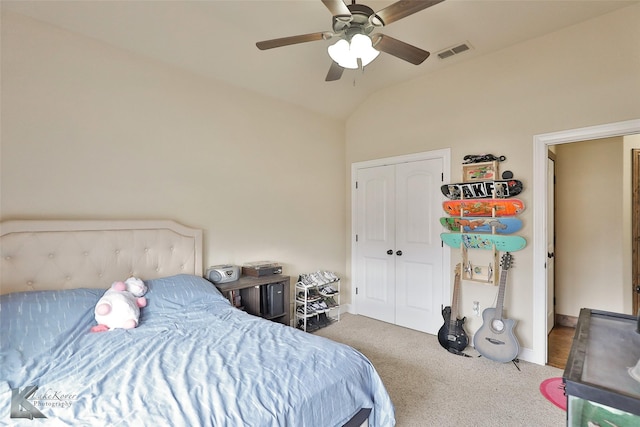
314;314;566;427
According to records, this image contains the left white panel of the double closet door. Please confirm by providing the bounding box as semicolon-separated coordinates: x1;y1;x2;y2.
356;165;396;323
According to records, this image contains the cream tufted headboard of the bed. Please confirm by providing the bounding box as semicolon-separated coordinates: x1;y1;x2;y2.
0;220;202;294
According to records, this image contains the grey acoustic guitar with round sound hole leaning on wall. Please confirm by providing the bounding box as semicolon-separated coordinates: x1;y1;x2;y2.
473;252;520;362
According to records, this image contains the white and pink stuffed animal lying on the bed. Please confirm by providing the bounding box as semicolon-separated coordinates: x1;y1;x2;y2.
91;277;147;332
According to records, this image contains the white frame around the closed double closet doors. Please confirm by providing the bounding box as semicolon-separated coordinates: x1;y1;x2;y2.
349;148;451;314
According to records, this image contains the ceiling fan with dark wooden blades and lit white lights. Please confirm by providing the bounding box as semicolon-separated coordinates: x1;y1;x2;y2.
256;0;444;81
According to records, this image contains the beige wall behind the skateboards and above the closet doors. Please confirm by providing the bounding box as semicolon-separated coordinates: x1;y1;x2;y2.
345;5;640;349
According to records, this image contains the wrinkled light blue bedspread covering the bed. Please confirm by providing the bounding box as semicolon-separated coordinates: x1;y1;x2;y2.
0;275;395;427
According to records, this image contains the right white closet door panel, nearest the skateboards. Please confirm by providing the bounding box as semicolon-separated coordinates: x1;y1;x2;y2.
395;159;445;334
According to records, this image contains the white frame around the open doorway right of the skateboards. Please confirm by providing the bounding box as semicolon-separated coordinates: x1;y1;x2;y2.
529;119;640;365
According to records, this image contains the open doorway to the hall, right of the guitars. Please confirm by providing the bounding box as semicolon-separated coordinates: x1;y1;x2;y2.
547;137;631;369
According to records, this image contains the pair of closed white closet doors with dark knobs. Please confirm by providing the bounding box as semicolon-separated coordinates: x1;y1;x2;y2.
355;159;443;334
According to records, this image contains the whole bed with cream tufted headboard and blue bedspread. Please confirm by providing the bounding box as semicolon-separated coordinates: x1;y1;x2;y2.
0;221;395;427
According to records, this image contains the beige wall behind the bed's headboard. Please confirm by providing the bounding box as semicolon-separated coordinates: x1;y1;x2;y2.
0;12;346;290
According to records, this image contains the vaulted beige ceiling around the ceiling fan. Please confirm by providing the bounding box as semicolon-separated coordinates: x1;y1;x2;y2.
2;0;638;119
